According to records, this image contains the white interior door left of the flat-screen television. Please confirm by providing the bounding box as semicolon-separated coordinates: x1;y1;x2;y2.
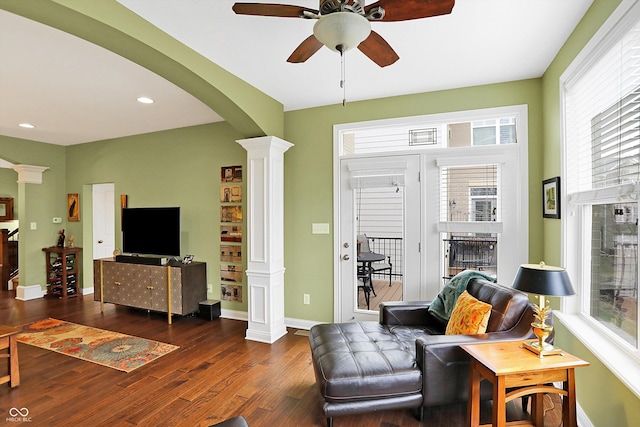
93;183;116;259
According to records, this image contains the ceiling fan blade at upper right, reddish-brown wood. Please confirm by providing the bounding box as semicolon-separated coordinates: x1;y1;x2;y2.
364;0;455;22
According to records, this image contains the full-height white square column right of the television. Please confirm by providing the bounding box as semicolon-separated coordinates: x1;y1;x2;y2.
237;136;293;344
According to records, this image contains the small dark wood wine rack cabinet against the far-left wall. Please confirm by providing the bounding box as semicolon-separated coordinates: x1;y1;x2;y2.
42;246;82;298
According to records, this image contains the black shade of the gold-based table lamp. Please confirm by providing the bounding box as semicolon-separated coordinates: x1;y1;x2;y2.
513;262;575;297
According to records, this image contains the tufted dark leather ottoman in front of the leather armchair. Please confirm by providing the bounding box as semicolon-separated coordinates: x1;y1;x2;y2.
309;322;422;426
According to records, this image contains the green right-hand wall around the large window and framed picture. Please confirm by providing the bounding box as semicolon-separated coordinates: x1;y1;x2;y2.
540;0;640;427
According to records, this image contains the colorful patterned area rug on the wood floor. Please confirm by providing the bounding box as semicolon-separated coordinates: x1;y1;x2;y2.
18;318;179;372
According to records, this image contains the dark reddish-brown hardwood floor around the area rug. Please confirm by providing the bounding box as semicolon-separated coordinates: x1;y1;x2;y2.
0;291;560;427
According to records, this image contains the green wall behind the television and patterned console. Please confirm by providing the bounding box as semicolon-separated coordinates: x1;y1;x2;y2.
66;122;247;311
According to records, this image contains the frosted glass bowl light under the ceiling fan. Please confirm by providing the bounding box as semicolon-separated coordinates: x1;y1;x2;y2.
313;12;371;52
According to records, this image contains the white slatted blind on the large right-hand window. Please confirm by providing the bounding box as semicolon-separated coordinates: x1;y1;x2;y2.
565;20;640;194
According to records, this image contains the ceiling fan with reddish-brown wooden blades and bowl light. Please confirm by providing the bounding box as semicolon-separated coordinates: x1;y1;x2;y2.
233;0;455;67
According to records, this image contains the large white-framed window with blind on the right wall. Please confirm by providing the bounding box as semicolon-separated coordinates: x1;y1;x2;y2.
561;3;640;393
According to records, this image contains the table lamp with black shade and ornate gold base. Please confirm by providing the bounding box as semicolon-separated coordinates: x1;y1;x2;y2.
513;261;575;358
